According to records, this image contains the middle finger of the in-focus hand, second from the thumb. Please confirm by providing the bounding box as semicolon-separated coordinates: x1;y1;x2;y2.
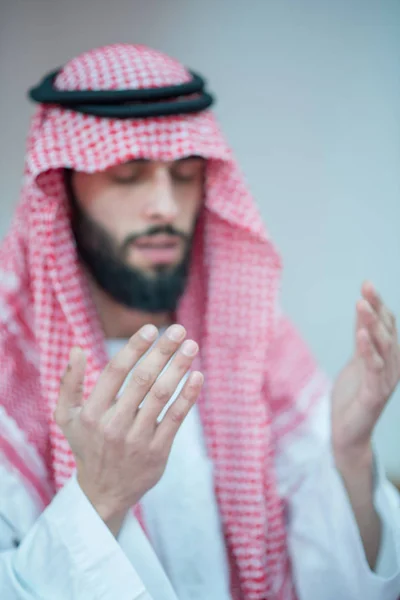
105;325;190;431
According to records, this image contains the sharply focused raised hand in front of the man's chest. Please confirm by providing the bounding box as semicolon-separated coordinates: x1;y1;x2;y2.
55;325;203;533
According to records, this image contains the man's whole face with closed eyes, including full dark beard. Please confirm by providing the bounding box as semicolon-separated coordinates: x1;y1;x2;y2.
66;157;205;313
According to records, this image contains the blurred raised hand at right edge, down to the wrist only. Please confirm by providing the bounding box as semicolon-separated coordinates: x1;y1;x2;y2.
332;283;400;462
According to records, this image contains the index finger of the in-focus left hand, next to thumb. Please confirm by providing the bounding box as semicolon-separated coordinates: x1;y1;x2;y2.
82;325;158;420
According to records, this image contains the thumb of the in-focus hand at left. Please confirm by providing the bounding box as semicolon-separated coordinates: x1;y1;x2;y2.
54;347;86;426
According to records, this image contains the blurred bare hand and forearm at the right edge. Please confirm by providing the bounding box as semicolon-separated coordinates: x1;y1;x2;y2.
332;282;400;567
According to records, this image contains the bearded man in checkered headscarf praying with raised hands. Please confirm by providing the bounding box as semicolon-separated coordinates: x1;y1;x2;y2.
0;45;400;600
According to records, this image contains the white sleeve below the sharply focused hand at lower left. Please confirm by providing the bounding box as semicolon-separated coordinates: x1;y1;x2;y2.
0;466;152;600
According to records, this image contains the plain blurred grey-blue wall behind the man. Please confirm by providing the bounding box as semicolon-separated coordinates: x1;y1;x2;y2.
0;0;400;479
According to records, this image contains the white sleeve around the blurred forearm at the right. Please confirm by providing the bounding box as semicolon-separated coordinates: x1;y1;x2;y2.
276;398;400;600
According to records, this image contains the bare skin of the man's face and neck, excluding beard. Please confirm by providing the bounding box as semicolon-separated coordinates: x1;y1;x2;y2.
72;157;205;338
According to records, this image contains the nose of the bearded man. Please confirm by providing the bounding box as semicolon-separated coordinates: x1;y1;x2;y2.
145;165;178;223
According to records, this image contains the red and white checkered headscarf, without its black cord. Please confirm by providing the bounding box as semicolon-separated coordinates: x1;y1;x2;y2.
0;44;328;600
